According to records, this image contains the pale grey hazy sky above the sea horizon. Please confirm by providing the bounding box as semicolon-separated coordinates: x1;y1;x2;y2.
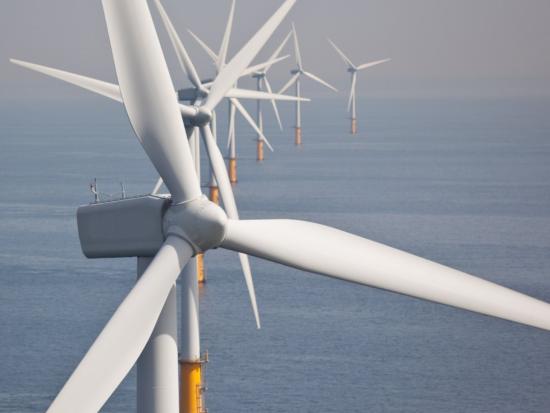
0;0;550;101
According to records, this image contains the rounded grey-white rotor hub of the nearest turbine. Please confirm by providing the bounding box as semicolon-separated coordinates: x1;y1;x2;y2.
163;196;227;254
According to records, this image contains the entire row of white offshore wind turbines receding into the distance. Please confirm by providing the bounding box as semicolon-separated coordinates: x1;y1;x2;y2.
8;0;550;413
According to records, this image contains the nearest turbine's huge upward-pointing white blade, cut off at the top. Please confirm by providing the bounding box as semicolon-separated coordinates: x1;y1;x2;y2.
103;0;201;204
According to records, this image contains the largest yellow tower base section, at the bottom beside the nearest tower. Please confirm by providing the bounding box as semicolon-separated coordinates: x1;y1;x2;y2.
179;360;206;413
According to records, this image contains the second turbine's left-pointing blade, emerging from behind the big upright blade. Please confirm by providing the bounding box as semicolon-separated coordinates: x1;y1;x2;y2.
10;59;122;102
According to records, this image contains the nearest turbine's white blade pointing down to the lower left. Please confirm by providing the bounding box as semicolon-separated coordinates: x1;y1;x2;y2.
47;235;193;413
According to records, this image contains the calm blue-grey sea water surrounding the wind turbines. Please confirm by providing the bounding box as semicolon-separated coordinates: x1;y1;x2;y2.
0;97;550;413
